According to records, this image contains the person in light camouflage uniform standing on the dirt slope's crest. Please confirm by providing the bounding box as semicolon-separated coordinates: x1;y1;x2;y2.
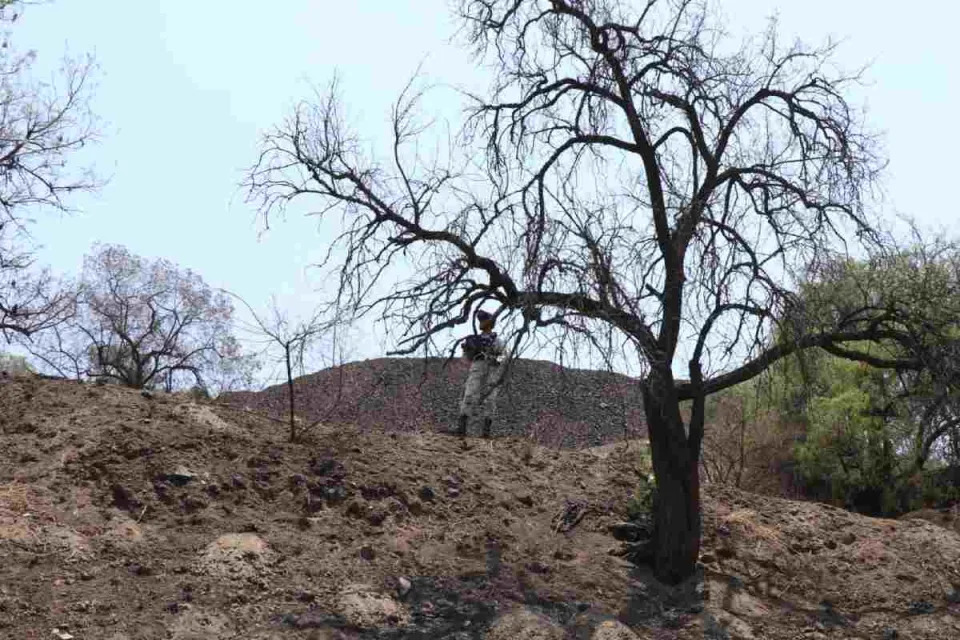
457;309;504;438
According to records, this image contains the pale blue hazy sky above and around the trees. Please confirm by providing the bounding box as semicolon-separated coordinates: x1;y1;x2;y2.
12;0;960;376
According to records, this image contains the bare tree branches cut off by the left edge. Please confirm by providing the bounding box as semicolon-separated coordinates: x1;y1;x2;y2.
0;0;97;341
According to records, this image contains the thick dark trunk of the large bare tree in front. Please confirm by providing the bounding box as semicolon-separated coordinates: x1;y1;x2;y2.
642;378;701;584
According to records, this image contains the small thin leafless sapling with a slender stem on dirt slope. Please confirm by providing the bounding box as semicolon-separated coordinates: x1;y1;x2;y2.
226;292;344;442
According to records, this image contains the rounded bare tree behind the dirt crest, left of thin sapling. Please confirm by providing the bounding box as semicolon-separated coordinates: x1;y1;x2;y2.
31;245;255;391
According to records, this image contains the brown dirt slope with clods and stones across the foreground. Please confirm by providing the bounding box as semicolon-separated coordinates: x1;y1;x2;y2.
0;377;960;640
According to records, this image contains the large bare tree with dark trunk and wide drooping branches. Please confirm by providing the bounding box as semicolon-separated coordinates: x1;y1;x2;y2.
247;0;944;582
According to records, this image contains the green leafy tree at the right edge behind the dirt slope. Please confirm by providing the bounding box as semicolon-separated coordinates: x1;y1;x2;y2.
775;240;960;515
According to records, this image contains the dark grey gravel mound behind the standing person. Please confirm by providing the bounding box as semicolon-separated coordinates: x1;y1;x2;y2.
222;358;646;447
